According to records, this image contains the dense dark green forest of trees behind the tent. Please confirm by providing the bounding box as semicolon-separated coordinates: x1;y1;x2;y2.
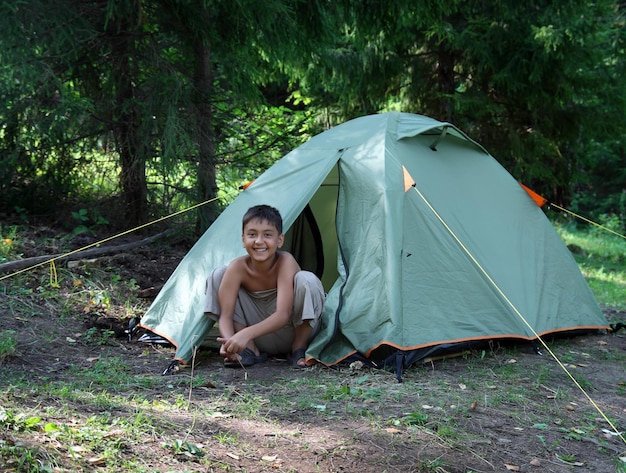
0;0;626;233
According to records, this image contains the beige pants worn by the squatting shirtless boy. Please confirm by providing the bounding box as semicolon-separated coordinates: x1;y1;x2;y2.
204;266;325;355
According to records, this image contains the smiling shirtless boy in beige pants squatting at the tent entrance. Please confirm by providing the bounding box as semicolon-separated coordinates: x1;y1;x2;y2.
205;205;325;368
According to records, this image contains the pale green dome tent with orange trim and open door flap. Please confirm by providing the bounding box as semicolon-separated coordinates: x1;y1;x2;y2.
140;112;608;372
